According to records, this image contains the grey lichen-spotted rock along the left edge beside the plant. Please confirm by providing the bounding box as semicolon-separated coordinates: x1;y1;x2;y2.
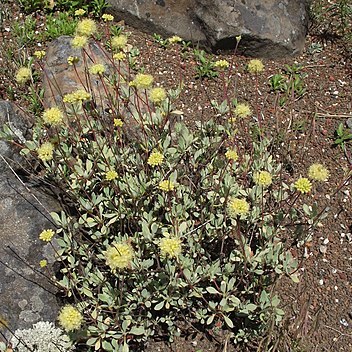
0;102;59;341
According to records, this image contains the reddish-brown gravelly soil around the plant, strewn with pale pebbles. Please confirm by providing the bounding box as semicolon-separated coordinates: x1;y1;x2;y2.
0;1;352;352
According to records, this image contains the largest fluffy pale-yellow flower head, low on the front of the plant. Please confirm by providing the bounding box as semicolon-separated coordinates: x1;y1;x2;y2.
105;242;134;272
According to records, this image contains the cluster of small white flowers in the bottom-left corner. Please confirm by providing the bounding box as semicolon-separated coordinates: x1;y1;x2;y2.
11;321;74;352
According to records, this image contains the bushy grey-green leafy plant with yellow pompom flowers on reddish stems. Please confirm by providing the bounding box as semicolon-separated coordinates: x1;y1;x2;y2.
2;15;329;351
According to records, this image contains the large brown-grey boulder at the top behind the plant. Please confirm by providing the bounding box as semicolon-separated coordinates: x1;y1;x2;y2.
108;0;308;58
